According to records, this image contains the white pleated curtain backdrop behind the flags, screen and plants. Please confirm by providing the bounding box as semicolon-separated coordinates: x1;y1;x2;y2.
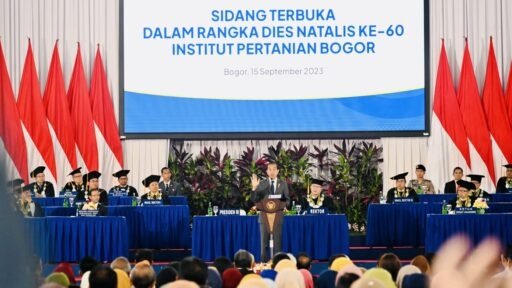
0;0;512;194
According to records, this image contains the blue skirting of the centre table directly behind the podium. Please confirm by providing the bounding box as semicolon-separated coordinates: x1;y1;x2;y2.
192;215;349;261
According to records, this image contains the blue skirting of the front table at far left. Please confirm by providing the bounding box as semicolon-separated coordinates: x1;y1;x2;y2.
24;217;128;263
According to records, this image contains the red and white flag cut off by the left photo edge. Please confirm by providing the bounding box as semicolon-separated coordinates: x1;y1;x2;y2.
0;42;29;183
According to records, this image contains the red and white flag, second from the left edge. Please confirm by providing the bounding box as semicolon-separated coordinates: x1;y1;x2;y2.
18;40;58;184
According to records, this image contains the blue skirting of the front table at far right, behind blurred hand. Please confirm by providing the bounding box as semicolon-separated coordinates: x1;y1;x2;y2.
425;213;512;253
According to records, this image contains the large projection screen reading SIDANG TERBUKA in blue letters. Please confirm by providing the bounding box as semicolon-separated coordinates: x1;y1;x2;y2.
121;0;428;138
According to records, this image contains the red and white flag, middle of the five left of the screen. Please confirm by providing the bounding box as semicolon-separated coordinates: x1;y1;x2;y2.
43;42;77;187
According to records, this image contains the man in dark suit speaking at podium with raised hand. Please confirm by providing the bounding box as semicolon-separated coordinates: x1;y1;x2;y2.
251;163;290;262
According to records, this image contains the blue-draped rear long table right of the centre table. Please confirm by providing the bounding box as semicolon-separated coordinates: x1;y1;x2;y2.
366;202;512;247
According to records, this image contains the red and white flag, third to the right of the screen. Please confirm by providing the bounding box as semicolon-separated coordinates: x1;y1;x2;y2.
482;38;512;176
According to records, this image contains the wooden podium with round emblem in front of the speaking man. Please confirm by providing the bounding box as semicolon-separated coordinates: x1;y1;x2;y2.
256;198;286;259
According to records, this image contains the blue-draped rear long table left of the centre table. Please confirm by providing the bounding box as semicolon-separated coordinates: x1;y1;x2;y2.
43;205;190;249
